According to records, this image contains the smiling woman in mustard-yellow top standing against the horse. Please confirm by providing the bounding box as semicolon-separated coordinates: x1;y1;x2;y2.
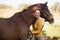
31;10;44;40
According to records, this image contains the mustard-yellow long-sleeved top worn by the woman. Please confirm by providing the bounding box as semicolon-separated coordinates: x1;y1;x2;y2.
32;18;43;37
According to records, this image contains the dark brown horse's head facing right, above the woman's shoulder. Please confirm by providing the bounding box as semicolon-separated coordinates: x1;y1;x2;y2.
40;2;54;24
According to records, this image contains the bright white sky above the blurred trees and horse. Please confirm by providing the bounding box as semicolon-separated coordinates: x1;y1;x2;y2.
0;0;60;8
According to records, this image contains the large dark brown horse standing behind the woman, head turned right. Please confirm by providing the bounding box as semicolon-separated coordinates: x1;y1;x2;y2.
0;3;54;40
